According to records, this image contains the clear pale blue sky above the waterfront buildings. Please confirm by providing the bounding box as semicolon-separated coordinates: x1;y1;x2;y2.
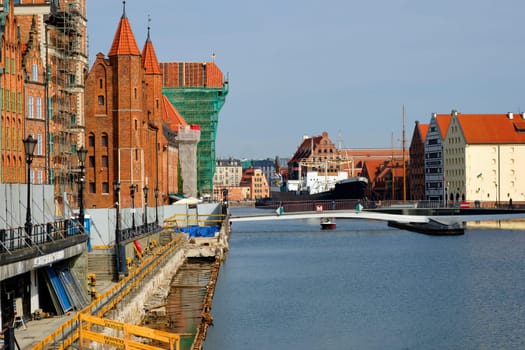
87;0;525;159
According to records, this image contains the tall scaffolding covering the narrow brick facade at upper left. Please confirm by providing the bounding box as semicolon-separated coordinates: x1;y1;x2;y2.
45;0;88;213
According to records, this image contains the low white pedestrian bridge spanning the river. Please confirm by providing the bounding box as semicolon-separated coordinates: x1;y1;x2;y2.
230;210;525;235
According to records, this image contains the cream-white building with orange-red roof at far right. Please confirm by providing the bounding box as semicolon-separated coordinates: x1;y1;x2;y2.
444;113;525;203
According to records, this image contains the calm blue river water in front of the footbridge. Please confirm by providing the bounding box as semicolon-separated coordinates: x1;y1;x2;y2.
204;209;525;350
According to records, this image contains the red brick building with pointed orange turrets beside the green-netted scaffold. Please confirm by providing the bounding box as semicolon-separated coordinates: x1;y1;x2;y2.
86;10;179;207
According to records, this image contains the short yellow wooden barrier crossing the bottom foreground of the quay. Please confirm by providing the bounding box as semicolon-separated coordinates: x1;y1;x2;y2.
79;314;180;350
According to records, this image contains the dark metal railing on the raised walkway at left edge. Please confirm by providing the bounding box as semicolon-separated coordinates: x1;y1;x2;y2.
0;219;83;254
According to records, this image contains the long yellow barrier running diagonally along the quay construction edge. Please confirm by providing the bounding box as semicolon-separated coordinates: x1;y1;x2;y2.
33;235;185;350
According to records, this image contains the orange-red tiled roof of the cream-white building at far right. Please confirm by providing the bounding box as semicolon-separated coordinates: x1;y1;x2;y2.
458;114;525;144
